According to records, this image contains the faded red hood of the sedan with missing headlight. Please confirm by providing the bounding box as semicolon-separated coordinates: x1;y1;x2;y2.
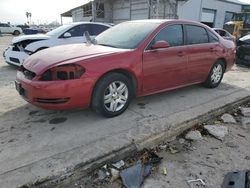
23;44;130;74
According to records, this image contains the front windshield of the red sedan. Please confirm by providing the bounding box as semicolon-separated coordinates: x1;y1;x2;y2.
95;22;159;49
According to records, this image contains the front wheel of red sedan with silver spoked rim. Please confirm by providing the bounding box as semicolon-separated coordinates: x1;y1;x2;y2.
92;73;133;117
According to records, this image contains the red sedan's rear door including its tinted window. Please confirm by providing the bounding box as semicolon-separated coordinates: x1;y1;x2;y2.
185;24;219;83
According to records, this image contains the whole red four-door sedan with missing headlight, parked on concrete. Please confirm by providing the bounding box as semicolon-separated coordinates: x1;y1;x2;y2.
15;20;235;117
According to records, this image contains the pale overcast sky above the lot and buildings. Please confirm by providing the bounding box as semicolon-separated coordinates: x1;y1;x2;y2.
0;0;250;24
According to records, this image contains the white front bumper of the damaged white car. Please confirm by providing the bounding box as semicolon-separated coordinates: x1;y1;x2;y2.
3;46;29;66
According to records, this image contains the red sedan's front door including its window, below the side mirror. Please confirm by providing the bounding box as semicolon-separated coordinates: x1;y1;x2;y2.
143;24;188;93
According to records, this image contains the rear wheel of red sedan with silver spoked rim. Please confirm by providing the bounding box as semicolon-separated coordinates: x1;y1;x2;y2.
203;60;225;88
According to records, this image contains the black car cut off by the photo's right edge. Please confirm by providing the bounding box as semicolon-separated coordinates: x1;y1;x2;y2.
236;35;250;66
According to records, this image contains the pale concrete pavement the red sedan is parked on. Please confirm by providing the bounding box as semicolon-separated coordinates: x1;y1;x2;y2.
0;36;250;188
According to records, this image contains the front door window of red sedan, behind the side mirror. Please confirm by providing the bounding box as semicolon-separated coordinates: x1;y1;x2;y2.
149;25;183;49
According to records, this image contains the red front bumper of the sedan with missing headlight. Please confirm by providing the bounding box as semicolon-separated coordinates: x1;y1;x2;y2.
15;71;93;110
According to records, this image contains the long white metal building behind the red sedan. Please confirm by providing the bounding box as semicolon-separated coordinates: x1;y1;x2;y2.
61;0;247;27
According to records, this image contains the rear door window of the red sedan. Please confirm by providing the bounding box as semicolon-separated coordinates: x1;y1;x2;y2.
186;25;208;44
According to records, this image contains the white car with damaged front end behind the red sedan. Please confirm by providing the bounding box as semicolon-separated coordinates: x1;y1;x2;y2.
3;22;111;66
